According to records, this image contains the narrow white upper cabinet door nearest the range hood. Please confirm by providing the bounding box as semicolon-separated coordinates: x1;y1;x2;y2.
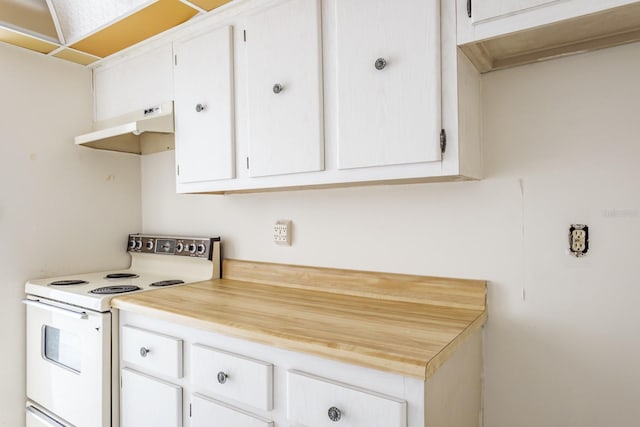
174;27;235;183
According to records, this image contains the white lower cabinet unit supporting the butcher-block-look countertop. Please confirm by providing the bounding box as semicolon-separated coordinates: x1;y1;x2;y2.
119;311;482;427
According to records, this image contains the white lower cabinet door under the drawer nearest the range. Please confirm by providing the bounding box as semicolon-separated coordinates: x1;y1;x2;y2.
120;368;182;427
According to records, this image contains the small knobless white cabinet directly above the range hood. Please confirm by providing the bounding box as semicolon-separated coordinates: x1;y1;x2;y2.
94;43;173;121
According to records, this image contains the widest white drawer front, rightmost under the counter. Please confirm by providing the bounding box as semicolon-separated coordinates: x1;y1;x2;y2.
287;371;407;427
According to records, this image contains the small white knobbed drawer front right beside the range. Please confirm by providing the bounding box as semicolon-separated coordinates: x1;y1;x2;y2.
120;325;182;378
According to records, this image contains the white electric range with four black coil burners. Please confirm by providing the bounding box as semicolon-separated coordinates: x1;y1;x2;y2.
23;234;221;427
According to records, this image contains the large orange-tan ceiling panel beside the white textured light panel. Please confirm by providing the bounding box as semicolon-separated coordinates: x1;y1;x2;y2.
71;0;198;57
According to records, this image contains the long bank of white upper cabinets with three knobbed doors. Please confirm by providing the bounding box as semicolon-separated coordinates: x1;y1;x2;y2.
91;0;480;193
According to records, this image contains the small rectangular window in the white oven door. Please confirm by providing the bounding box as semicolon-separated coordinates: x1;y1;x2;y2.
42;325;82;374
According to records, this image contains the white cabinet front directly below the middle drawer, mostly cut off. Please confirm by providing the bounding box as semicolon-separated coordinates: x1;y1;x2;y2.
191;394;273;427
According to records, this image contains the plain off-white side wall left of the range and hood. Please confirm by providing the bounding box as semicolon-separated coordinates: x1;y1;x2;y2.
0;43;141;427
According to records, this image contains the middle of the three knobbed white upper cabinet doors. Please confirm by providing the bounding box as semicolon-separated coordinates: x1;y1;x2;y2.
245;0;324;177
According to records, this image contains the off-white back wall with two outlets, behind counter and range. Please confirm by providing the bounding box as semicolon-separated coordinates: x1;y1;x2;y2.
142;44;640;427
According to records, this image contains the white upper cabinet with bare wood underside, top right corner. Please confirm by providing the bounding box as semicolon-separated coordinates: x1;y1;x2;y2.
456;0;640;72
